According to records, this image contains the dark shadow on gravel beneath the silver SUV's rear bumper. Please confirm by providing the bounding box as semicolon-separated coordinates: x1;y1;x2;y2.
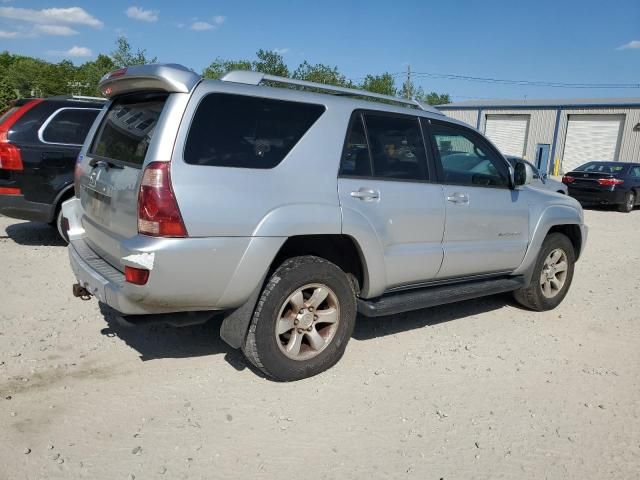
100;303;262;376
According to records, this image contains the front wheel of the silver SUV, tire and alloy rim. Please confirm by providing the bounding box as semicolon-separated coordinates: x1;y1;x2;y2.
513;233;576;312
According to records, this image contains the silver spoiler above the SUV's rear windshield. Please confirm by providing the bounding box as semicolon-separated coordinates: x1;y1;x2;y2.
98;63;202;98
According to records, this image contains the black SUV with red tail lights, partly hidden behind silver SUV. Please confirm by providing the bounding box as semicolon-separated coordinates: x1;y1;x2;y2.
0;96;105;240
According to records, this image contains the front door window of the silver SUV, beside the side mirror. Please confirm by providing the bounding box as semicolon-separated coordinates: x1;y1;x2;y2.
431;123;509;187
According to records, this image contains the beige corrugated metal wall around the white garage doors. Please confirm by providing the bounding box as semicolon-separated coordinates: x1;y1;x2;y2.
442;107;640;172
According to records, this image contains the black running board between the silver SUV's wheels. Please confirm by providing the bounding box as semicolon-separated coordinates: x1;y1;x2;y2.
358;277;525;317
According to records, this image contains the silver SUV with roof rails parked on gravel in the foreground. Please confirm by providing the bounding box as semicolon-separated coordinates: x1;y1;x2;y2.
64;65;587;381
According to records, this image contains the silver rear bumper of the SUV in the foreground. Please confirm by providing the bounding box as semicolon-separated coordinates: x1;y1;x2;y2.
63;198;285;315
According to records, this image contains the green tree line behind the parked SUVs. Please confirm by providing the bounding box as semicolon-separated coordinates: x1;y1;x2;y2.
0;37;450;111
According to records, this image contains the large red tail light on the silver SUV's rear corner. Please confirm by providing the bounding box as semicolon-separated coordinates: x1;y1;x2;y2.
138;162;187;237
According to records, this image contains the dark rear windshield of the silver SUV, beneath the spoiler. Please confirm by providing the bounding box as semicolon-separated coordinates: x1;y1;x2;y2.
90;94;167;166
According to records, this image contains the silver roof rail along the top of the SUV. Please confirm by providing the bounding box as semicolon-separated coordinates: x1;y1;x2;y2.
220;70;442;115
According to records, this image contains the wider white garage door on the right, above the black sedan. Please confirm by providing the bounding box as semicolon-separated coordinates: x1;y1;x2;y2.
562;115;624;172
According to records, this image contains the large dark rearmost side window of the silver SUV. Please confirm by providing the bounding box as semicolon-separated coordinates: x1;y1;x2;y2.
184;93;325;168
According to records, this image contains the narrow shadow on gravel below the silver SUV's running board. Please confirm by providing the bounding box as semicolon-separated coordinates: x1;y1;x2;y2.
352;294;514;340
